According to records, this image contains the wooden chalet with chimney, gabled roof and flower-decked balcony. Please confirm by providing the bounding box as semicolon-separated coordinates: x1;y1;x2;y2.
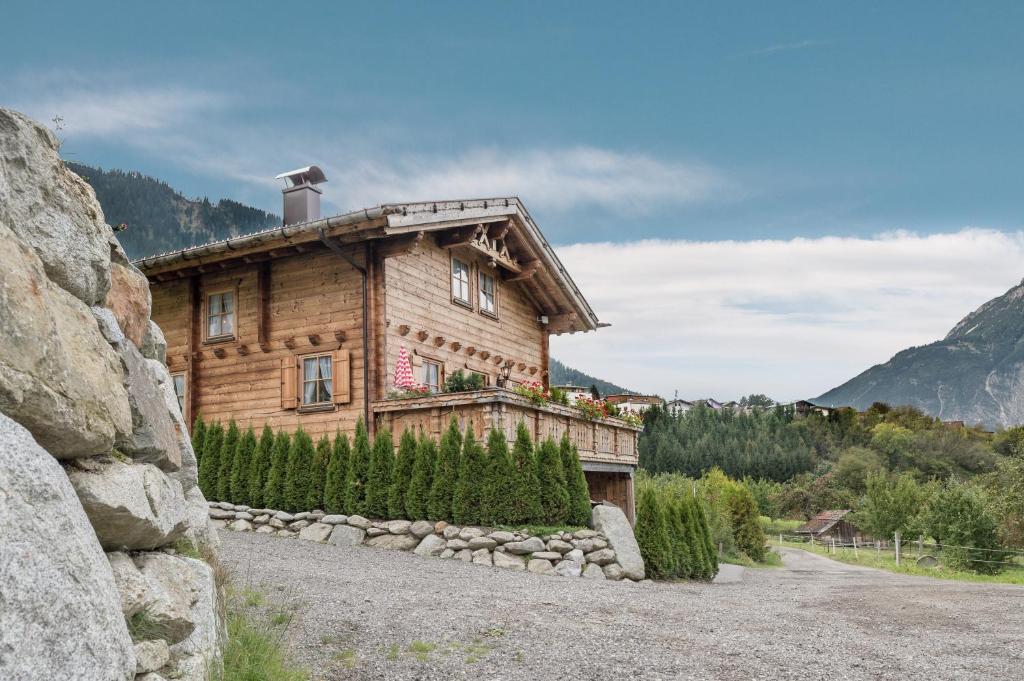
135;166;639;518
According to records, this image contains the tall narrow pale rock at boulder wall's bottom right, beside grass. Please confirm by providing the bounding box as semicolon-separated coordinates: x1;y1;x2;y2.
171;556;226;681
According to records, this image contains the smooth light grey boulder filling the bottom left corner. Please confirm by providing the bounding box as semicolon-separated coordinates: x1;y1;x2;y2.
0;411;135;680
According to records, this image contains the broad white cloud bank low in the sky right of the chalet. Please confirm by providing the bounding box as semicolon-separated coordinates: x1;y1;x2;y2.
551;229;1024;399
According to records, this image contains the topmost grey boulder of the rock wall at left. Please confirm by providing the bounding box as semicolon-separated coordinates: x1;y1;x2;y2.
0;109;113;305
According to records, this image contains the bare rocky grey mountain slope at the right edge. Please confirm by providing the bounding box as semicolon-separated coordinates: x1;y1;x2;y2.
813;282;1024;427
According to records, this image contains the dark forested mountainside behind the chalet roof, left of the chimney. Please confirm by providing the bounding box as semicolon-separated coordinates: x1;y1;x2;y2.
67;162;281;258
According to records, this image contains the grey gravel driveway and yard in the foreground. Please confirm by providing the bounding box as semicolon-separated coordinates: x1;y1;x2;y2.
220;531;1024;680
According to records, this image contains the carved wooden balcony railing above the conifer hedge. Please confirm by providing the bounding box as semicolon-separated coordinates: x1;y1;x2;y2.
372;388;641;466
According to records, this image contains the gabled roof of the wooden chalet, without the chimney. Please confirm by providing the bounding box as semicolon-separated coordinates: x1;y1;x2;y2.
135;197;608;333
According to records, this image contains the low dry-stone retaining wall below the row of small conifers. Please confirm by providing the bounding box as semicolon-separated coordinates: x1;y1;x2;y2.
209;502;644;581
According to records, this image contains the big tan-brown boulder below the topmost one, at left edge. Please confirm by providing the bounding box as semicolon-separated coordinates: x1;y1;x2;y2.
0;222;131;459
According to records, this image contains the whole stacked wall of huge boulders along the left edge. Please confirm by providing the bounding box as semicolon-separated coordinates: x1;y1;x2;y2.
0;109;223;681
